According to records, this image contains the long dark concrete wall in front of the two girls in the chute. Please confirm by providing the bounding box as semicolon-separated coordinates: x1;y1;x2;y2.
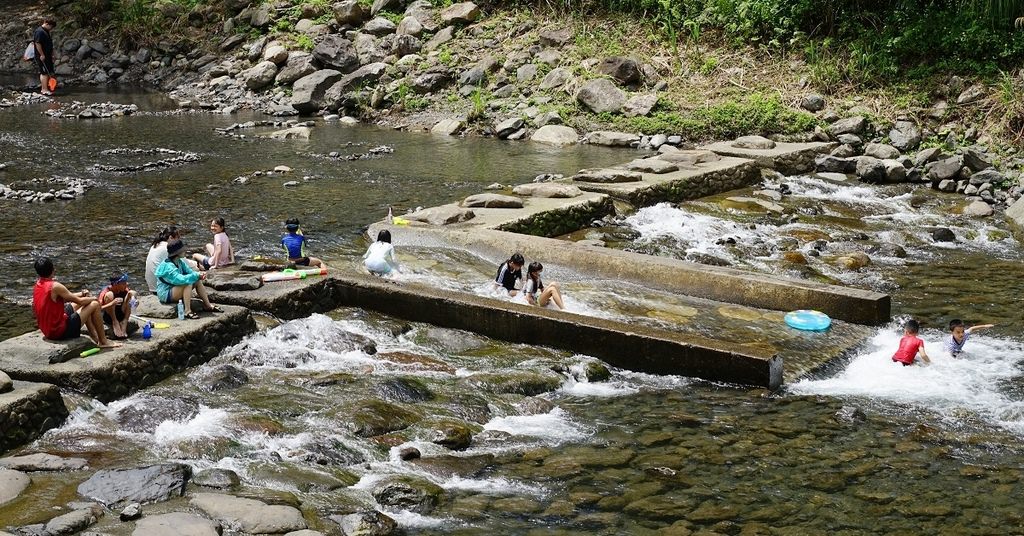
331;276;782;389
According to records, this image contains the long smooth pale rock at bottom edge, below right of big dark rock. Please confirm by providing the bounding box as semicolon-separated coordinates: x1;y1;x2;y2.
189;493;306;534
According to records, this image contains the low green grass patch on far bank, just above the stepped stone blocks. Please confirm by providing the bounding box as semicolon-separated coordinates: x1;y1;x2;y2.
601;93;817;140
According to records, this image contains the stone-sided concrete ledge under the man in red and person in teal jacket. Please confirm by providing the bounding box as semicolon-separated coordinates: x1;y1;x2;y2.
0;306;256;403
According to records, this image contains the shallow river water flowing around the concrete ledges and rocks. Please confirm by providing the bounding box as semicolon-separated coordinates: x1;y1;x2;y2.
0;86;1024;535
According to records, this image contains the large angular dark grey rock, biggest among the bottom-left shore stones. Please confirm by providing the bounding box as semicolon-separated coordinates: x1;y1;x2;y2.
78;463;191;508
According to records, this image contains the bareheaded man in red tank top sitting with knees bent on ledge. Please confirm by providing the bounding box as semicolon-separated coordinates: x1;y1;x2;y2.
32;257;121;348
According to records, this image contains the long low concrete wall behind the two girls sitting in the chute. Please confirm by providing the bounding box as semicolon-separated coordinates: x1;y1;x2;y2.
371;223;892;325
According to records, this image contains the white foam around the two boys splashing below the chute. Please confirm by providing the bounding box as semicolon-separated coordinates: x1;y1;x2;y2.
788;327;1024;437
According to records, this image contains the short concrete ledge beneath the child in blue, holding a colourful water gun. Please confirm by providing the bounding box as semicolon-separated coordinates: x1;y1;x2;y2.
210;276;338;320
